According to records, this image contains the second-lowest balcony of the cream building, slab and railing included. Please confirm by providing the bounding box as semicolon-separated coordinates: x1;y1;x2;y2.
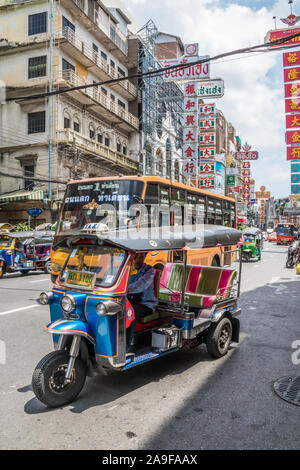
55;69;139;133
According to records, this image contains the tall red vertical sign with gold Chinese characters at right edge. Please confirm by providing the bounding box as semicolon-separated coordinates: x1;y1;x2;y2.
283;51;300;195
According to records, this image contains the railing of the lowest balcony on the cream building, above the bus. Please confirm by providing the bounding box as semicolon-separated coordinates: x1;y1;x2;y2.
56;129;139;171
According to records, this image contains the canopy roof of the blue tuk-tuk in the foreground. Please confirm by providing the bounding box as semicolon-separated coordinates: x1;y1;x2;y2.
62;225;242;251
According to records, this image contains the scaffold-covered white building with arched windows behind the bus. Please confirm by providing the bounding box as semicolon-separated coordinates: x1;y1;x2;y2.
129;20;183;181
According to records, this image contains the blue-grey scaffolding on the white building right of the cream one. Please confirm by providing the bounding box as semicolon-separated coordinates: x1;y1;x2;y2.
137;20;183;177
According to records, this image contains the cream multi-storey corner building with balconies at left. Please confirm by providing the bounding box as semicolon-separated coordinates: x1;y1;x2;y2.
0;0;139;223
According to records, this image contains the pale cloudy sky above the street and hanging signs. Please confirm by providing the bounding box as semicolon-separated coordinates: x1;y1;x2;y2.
123;0;300;198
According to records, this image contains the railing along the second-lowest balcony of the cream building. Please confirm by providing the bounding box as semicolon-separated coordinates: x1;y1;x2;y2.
55;69;139;130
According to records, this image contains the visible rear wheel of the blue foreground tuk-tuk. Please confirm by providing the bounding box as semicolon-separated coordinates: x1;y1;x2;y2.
206;318;232;357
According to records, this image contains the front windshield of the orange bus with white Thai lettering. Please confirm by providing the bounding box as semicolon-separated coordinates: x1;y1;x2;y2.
57;180;144;235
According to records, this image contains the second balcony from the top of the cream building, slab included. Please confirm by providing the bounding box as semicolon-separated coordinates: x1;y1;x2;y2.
56;27;137;101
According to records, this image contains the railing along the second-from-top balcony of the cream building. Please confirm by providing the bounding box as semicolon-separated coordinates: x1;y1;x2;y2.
62;27;137;98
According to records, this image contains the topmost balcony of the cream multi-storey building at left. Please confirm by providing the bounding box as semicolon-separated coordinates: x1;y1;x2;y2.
60;0;128;64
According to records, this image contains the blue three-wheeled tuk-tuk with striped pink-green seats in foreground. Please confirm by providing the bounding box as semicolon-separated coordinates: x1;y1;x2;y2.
32;225;241;407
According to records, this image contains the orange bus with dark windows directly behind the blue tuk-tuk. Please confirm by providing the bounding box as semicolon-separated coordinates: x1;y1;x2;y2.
52;176;237;280
